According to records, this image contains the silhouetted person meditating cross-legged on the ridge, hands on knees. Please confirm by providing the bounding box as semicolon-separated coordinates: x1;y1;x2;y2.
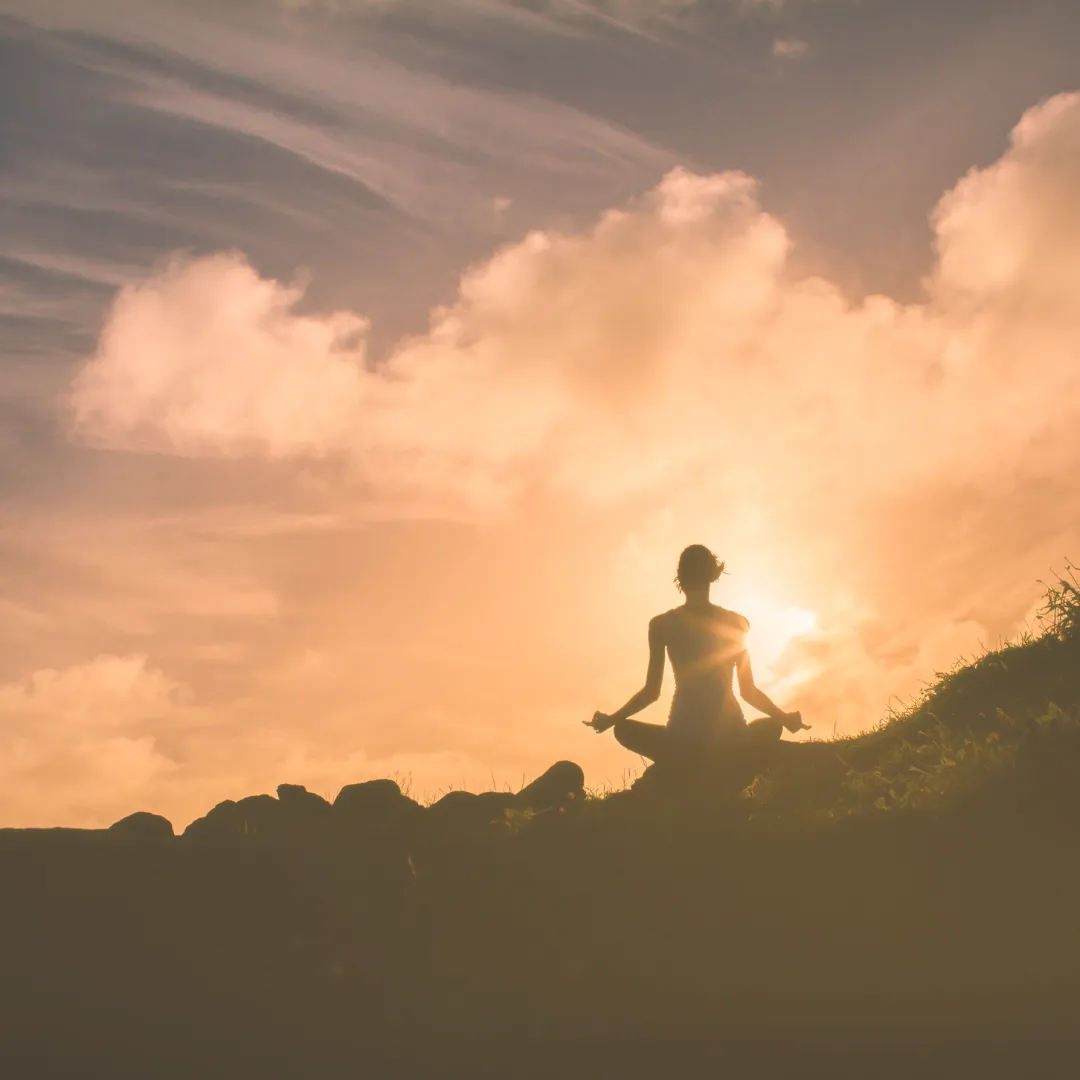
584;544;807;761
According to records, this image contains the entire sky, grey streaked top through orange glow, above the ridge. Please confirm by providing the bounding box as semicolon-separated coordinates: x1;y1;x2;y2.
0;0;1080;826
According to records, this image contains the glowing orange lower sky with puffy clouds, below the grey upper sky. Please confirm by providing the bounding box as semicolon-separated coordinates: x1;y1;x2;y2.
6;2;1080;825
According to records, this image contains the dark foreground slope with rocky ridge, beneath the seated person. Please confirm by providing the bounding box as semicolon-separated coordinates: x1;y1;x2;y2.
0;583;1080;1080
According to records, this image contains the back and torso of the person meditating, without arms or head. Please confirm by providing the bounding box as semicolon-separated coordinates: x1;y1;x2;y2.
662;604;750;735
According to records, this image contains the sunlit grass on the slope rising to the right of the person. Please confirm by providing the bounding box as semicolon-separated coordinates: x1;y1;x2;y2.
745;564;1080;821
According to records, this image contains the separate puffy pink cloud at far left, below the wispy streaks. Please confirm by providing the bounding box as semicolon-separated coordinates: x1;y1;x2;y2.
73;255;367;457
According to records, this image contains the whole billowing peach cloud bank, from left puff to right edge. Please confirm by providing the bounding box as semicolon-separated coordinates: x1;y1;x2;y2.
71;96;1080;501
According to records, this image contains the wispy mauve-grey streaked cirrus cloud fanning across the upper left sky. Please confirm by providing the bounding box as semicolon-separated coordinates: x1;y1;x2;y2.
0;0;673;358
